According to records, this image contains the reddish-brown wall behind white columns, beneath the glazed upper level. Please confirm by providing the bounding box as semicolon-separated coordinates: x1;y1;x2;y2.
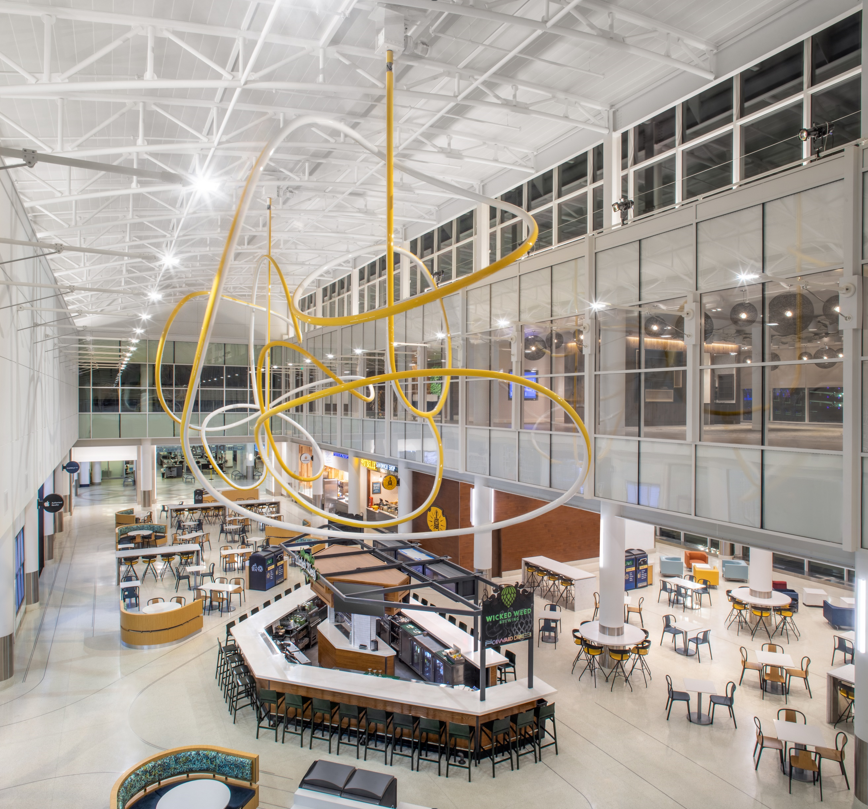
413;472;600;576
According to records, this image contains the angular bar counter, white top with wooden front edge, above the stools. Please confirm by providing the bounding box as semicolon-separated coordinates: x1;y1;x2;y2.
231;585;557;726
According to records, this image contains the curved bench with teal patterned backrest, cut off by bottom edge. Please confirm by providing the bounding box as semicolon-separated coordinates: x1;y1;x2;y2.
109;745;259;809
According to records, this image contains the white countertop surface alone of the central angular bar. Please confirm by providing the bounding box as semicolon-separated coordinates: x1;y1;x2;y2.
231;585;557;716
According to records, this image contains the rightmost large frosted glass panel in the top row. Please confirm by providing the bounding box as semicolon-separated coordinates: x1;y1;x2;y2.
764;181;844;277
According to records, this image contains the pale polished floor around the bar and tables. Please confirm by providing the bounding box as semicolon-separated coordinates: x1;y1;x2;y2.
0;481;853;809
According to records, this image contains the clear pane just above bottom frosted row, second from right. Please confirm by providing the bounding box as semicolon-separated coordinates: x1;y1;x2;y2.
701;365;763;445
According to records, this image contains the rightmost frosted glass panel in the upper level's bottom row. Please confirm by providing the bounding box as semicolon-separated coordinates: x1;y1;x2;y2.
763;450;843;545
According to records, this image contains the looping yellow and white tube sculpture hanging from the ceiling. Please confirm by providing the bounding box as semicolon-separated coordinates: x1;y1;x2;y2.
156;51;591;539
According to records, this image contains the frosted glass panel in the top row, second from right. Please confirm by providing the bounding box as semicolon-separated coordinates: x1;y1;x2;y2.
696;205;763;289
